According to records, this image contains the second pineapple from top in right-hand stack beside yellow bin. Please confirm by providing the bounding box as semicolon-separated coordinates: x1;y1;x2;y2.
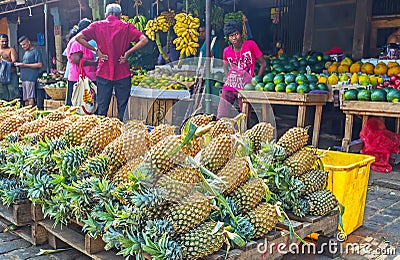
283;150;318;176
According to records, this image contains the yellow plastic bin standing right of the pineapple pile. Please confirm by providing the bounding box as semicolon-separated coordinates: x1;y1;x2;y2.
319;150;375;235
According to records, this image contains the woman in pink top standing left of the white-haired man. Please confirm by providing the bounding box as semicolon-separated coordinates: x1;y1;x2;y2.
65;18;97;106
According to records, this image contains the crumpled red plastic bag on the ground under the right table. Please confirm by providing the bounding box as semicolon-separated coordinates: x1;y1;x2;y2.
360;117;400;172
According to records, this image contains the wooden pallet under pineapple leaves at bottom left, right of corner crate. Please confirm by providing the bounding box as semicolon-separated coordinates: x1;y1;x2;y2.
38;219;123;260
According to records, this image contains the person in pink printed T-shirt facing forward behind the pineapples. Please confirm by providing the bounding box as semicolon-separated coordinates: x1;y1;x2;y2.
217;21;267;119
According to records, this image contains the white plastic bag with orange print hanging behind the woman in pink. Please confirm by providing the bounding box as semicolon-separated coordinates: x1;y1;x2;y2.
71;59;97;115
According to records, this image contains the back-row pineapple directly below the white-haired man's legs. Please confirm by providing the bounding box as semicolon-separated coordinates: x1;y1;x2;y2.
82;117;122;156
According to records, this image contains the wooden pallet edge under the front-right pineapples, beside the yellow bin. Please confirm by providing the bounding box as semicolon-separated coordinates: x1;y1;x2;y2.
205;210;339;260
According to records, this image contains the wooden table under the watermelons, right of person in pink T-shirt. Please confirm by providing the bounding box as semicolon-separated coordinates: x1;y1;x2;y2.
238;90;328;147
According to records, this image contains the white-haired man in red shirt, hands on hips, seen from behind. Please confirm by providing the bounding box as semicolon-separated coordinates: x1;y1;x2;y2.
76;4;148;120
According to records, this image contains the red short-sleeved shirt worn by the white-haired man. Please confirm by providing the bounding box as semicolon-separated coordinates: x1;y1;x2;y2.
82;16;143;80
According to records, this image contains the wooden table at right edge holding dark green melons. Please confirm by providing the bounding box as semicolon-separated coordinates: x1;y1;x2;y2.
340;100;400;152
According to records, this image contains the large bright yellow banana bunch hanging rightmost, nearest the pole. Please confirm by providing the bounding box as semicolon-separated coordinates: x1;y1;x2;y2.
173;13;200;58
